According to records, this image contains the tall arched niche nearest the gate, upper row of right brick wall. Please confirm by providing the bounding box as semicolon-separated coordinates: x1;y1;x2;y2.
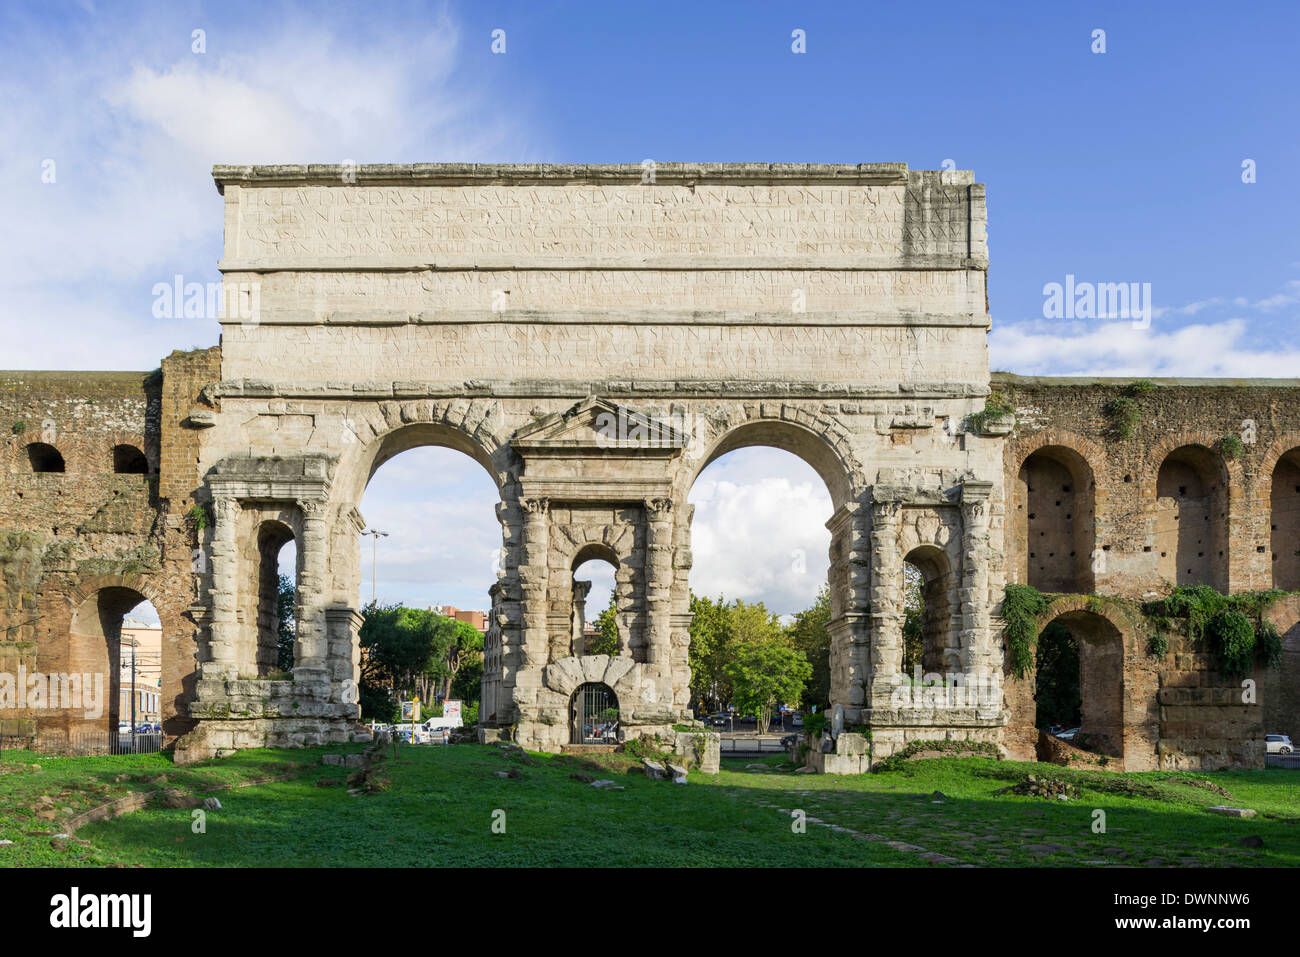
1014;446;1095;593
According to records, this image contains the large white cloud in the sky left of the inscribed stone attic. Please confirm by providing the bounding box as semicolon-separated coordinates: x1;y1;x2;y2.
0;10;536;369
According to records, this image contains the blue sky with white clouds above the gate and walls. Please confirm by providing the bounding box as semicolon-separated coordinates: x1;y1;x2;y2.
0;1;1300;610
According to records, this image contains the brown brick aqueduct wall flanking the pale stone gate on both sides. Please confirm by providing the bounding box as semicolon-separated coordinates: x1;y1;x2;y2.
0;358;1300;770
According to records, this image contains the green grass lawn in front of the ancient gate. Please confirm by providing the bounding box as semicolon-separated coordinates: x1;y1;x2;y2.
0;745;1300;867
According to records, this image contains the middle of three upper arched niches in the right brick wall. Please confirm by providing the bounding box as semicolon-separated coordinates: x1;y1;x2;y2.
1156;445;1227;592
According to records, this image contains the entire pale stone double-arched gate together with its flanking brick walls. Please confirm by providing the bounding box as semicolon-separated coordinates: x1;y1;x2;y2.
0;164;1300;768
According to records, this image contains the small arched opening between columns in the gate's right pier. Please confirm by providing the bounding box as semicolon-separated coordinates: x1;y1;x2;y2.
902;545;962;676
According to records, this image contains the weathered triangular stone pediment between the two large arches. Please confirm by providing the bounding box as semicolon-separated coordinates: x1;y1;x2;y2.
511;395;690;452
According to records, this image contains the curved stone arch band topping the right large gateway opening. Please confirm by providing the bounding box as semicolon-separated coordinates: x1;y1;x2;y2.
675;403;867;510
